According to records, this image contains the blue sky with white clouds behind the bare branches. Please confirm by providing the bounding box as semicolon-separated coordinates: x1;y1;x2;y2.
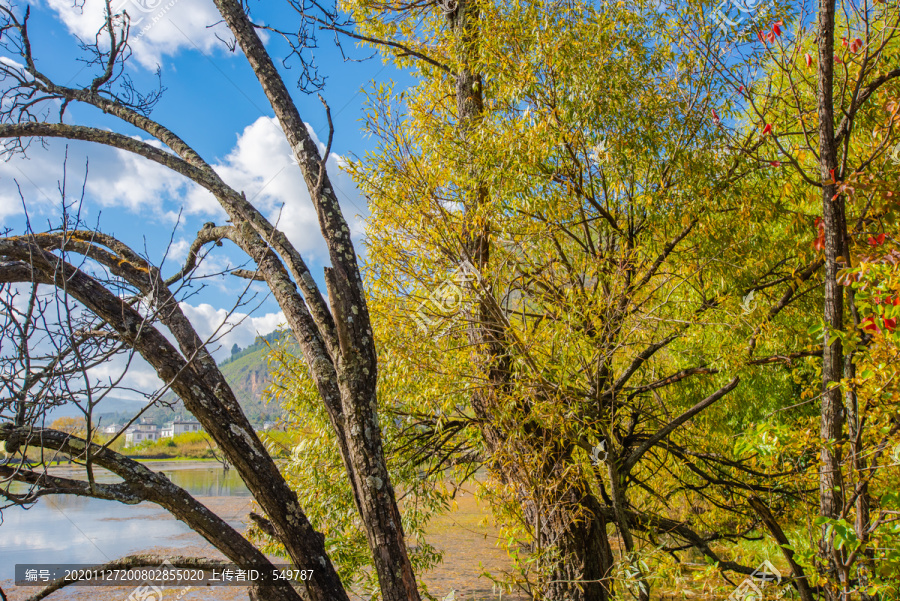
0;0;411;398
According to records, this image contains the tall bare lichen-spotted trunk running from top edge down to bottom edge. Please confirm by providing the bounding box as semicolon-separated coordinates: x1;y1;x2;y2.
215;0;419;601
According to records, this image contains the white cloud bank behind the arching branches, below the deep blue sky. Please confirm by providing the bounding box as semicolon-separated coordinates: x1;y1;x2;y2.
0;117;368;262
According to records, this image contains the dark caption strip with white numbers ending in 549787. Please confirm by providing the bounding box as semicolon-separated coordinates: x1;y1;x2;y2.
15;562;313;588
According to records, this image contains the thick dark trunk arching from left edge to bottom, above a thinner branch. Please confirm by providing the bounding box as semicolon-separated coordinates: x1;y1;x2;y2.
0;244;338;601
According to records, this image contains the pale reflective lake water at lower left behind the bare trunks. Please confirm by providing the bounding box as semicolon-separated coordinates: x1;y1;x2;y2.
0;462;251;581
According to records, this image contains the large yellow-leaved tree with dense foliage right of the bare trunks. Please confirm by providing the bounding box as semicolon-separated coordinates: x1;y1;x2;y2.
262;0;852;600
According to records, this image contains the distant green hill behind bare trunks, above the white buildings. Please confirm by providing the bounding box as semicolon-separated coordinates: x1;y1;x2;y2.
116;330;287;426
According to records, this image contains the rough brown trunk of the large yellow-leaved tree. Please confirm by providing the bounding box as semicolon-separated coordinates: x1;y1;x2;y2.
449;0;614;601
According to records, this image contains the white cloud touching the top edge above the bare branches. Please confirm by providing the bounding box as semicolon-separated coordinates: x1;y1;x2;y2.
47;0;230;69
